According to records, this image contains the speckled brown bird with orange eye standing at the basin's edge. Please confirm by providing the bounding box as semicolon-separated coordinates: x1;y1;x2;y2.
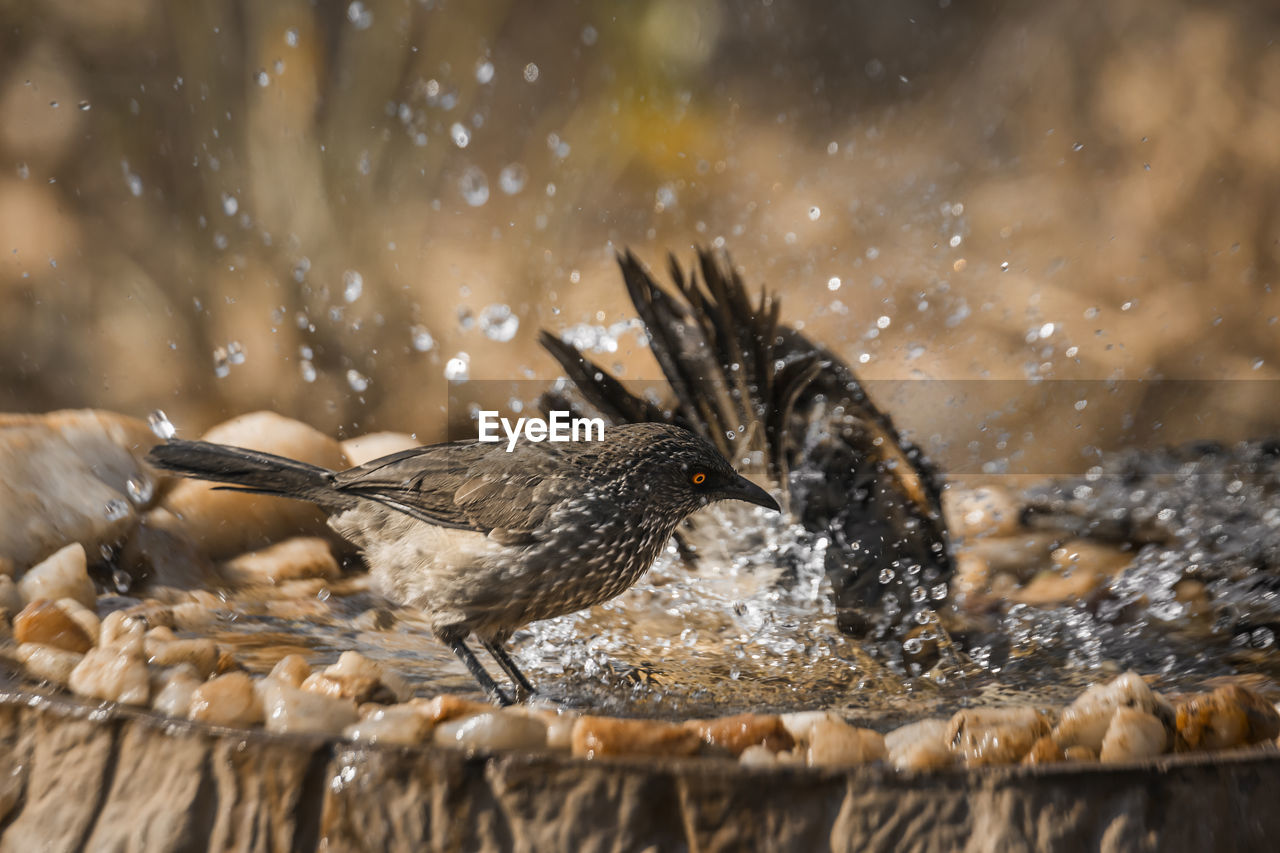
148;423;781;704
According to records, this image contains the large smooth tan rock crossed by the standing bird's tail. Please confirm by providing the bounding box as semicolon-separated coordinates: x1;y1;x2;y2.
144;411;348;560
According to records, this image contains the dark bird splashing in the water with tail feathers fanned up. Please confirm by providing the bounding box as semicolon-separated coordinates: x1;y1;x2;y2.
541;251;954;656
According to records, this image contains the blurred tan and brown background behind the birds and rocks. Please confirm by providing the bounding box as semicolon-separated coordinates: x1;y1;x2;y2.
0;0;1280;474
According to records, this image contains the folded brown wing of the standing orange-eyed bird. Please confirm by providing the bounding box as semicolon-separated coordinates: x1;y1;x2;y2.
334;442;573;542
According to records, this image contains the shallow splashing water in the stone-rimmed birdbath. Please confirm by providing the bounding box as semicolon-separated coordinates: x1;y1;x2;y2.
183;471;1276;727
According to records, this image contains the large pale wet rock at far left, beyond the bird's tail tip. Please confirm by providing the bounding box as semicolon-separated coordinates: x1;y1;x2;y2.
0;410;157;568
